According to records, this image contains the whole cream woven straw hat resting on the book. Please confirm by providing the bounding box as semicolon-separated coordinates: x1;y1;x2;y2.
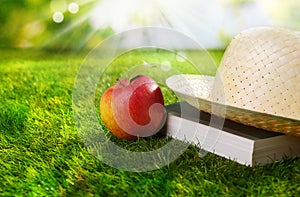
166;27;300;136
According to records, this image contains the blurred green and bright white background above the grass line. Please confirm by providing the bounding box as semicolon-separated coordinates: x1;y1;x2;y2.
0;0;300;49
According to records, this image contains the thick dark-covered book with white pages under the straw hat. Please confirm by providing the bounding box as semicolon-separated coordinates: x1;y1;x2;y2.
164;102;300;166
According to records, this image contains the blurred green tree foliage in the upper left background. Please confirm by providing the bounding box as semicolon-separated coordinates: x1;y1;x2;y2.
0;0;113;49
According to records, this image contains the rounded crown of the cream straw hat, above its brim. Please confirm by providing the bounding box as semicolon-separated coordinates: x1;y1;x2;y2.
218;27;300;120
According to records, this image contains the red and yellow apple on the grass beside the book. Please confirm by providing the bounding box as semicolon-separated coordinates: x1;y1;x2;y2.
100;75;166;140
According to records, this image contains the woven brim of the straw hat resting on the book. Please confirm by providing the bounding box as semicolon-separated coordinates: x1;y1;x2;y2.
166;74;300;136
